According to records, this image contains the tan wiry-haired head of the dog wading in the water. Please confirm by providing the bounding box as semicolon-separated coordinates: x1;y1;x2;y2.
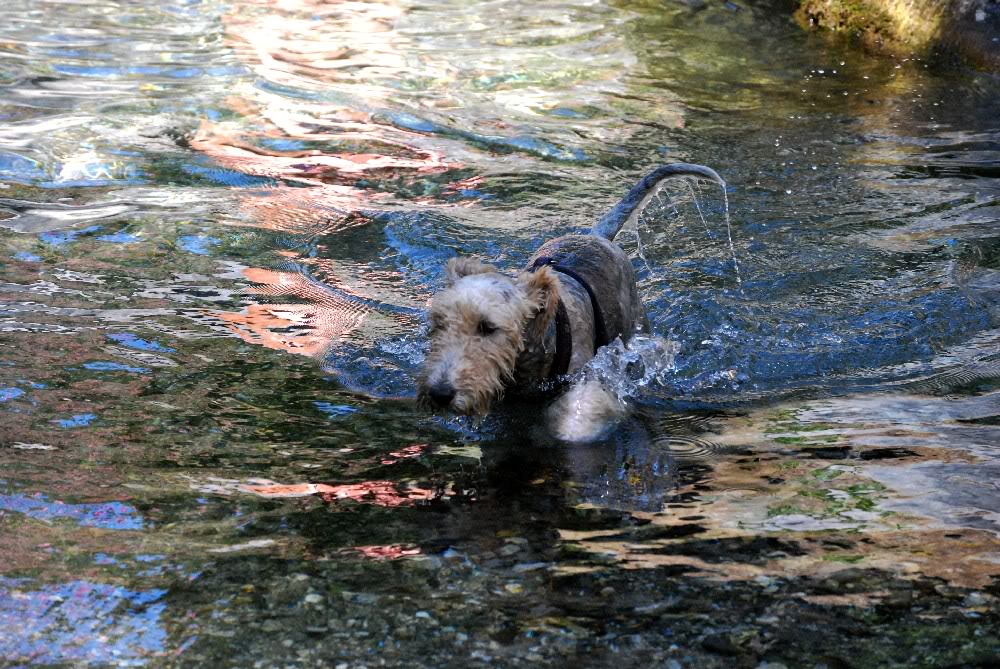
417;258;559;414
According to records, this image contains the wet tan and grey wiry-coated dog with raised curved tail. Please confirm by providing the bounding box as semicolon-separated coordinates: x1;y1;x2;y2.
417;163;724;434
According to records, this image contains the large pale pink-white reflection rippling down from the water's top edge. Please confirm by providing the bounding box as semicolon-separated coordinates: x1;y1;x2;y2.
191;0;461;232
